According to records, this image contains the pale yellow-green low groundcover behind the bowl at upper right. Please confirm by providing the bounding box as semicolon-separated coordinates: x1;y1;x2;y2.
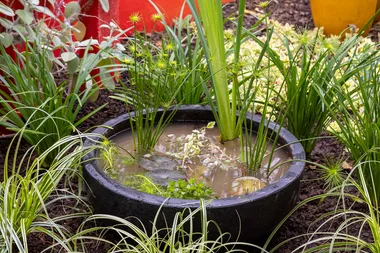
232;18;376;117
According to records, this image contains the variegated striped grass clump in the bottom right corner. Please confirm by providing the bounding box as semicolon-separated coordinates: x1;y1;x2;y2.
264;160;380;253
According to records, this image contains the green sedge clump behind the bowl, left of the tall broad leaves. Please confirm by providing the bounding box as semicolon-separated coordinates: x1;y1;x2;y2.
149;0;210;105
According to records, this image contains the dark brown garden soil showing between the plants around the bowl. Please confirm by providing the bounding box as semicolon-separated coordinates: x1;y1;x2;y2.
0;0;377;253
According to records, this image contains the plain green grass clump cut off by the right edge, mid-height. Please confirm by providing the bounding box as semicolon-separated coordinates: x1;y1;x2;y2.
326;57;380;206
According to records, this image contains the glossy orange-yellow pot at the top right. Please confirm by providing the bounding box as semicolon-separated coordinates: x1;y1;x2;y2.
310;0;378;36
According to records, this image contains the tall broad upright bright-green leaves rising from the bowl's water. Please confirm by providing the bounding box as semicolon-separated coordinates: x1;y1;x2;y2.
187;0;245;141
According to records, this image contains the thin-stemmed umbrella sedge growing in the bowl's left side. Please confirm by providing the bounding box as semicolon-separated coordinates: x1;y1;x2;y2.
111;14;186;156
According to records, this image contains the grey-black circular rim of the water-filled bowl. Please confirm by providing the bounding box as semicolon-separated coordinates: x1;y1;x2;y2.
83;105;306;209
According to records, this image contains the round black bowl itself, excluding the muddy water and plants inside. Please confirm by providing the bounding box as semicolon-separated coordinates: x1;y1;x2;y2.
84;105;305;243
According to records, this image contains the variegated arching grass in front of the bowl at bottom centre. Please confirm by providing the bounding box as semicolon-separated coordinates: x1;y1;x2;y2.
62;201;266;253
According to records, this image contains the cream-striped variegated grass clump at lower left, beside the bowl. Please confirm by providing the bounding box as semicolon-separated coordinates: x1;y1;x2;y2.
0;129;98;253
